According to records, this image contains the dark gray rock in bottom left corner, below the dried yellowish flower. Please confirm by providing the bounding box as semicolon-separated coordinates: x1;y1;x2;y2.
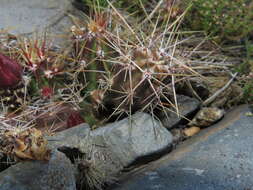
0;151;76;190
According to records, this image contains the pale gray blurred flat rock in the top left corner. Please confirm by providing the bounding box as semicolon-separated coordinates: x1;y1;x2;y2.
0;0;74;46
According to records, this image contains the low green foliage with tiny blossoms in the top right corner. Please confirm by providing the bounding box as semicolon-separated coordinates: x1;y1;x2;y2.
189;0;253;40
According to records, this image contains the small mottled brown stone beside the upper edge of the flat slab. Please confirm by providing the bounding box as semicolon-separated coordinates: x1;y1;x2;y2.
188;107;225;127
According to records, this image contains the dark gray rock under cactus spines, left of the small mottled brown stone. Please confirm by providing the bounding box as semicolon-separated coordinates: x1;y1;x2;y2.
158;95;200;129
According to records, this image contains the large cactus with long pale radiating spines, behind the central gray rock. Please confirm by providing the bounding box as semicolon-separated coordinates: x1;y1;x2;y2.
68;2;202;124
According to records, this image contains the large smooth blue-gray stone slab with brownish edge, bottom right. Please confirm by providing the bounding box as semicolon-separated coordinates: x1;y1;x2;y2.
114;106;253;190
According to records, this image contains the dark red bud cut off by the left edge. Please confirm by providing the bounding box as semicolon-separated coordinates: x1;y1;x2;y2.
0;53;22;88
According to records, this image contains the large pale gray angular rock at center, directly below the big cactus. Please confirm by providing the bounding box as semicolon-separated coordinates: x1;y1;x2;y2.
48;113;172;175
